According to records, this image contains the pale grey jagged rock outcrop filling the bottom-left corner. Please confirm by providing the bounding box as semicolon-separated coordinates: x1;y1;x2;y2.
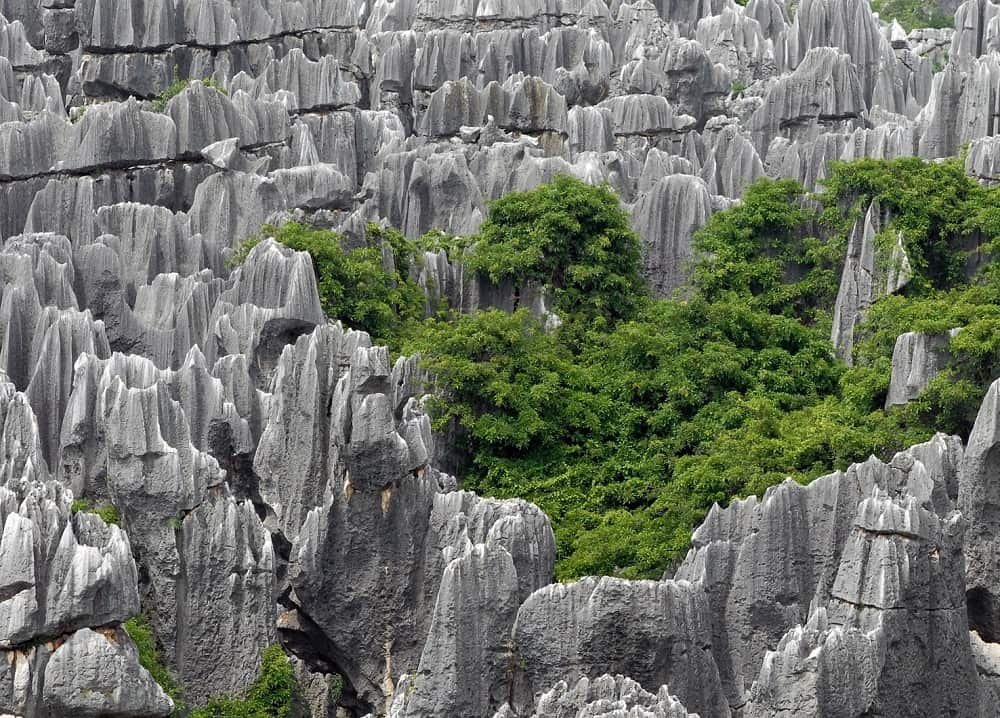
0;376;173;718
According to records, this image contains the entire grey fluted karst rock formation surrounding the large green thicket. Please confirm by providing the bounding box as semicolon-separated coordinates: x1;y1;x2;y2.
0;0;1000;718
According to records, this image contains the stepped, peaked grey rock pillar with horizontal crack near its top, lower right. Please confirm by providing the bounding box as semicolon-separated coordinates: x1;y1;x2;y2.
747;490;988;716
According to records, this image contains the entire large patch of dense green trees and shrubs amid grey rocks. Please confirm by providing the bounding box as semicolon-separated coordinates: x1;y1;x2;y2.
246;167;1000;578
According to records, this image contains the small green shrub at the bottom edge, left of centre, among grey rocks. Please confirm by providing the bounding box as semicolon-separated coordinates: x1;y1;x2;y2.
190;645;298;718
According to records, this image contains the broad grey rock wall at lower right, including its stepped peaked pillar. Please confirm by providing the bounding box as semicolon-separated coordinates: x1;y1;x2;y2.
677;422;993;716
